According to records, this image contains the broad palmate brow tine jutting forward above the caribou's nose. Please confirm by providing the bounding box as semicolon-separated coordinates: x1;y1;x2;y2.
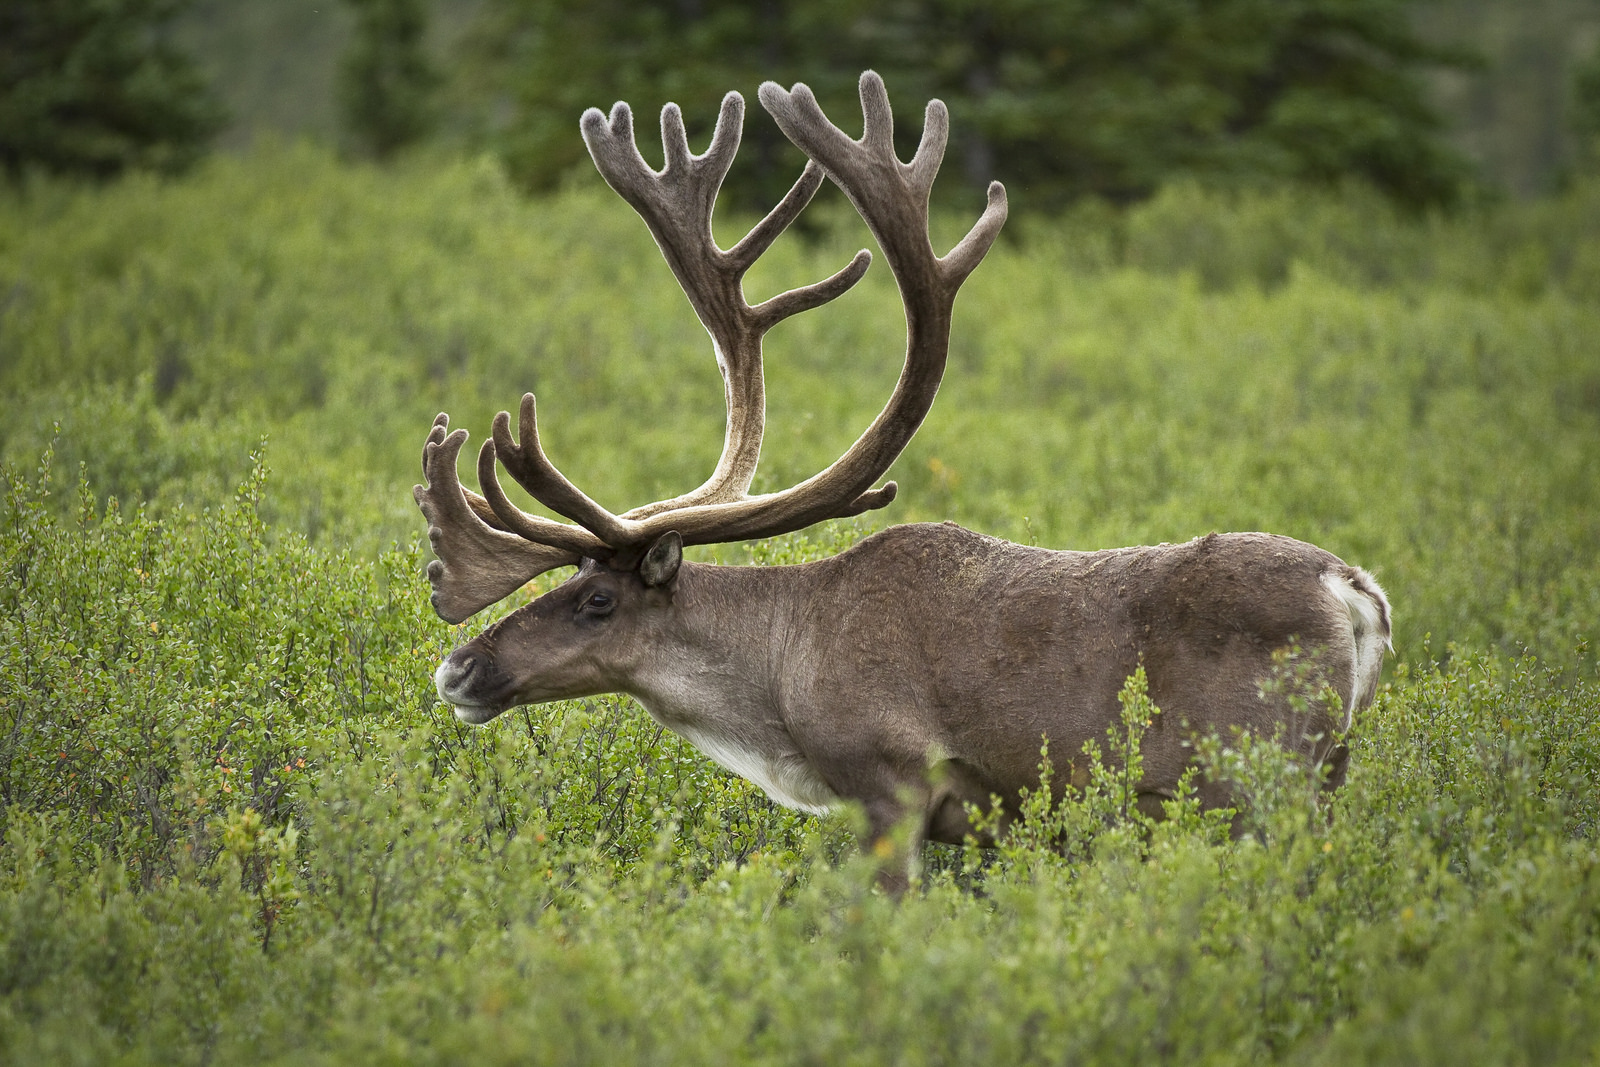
411;414;579;622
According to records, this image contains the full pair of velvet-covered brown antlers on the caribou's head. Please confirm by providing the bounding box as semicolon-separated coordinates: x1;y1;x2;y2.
416;70;1006;617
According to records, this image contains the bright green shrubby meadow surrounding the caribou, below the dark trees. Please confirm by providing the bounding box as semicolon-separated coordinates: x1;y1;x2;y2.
0;146;1600;1064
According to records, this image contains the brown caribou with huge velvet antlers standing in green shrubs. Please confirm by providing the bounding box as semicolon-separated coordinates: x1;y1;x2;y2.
414;70;1390;888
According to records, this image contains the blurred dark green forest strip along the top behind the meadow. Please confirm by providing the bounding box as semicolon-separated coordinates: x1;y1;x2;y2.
9;0;1600;213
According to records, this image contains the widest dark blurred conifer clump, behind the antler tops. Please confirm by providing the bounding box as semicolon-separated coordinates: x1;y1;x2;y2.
478;0;1467;210
